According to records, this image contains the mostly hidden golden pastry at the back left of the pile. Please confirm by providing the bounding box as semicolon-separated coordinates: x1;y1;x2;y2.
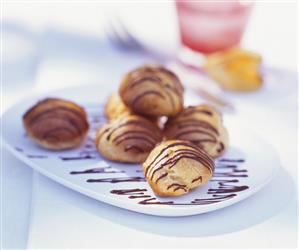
105;93;133;121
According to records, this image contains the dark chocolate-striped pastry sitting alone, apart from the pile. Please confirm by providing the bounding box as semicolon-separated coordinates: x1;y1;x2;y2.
23;98;89;150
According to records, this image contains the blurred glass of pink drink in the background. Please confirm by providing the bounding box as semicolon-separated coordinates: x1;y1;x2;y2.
176;0;252;53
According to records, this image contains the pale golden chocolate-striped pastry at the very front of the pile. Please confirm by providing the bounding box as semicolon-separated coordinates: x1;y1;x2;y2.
143;140;214;196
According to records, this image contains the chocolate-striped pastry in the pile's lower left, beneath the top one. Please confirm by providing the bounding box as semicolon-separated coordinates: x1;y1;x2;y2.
95;115;162;163
